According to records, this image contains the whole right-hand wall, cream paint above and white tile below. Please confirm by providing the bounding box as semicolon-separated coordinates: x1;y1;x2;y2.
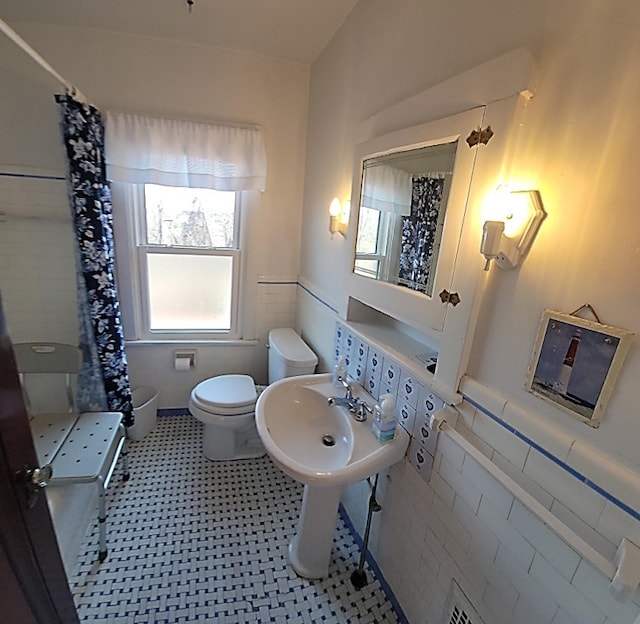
299;0;640;624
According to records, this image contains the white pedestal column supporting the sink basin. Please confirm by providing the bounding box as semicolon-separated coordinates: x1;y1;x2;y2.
289;485;342;579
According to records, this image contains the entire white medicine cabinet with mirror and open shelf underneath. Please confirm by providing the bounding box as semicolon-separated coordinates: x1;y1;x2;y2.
344;92;527;404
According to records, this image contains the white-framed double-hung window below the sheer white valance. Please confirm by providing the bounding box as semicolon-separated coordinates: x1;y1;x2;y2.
114;184;242;340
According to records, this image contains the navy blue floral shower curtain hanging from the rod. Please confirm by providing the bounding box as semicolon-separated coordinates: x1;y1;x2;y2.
56;95;133;426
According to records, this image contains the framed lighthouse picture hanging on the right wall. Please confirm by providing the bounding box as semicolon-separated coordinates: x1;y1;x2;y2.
526;310;633;427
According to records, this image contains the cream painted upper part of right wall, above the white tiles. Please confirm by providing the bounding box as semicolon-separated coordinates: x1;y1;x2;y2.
301;0;640;466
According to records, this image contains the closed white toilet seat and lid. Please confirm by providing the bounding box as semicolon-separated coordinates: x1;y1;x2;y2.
191;375;258;416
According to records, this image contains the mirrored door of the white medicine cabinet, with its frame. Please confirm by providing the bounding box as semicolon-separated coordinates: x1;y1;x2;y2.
347;107;483;335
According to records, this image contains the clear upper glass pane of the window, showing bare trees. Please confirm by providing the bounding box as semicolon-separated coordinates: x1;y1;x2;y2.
144;184;237;248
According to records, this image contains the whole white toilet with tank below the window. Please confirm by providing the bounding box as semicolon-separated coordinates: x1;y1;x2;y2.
189;328;318;460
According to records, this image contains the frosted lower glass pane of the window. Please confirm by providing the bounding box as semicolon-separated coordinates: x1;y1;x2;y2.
147;252;233;331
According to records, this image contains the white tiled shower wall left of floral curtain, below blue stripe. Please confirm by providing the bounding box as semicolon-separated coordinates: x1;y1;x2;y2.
0;172;78;343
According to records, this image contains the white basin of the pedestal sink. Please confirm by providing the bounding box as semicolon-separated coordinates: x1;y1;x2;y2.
256;374;409;487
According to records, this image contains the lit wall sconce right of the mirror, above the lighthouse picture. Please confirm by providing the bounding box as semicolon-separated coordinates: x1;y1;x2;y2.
480;188;547;271
